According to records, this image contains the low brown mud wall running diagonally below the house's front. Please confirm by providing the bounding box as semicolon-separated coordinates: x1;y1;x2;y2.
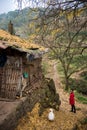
0;89;40;130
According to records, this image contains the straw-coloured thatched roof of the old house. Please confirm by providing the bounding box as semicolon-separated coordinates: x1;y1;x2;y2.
0;30;45;53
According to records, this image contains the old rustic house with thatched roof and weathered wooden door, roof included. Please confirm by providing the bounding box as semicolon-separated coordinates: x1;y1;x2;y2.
0;30;45;99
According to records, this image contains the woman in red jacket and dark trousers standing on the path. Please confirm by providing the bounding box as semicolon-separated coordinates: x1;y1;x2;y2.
69;90;76;113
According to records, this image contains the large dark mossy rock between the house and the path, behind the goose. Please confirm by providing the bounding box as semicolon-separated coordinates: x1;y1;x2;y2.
39;78;61;115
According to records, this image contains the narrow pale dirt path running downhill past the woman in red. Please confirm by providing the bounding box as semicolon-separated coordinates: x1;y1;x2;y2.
52;63;87;115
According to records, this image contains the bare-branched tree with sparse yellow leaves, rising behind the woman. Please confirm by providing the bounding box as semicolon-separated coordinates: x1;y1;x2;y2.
15;0;87;90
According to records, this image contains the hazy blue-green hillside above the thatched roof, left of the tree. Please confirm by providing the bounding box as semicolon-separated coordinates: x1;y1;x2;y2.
0;8;33;37
